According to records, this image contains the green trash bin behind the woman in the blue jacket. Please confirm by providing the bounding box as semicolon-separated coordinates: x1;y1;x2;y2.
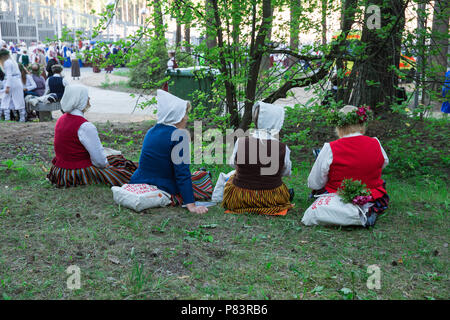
166;67;218;108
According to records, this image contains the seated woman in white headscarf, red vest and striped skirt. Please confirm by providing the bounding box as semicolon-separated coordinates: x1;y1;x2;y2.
47;86;137;187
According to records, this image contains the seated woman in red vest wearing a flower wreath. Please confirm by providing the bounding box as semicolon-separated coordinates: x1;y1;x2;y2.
308;105;389;225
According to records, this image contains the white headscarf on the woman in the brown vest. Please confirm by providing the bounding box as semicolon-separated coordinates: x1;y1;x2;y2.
252;101;284;139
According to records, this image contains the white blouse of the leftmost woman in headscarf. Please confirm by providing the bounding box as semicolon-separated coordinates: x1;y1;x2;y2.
70;109;108;168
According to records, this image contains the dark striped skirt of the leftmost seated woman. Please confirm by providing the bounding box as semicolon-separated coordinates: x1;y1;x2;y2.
47;155;137;187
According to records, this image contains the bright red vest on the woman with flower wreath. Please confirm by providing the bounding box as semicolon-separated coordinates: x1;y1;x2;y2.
325;136;386;199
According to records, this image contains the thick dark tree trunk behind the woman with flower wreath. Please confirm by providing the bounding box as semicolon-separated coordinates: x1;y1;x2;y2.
350;0;405;115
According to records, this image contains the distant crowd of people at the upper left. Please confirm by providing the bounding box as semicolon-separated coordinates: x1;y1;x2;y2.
0;41;126;122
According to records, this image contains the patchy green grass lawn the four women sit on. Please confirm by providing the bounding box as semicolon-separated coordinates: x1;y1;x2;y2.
0;120;450;299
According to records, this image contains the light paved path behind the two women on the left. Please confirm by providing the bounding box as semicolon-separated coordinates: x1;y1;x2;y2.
53;68;156;122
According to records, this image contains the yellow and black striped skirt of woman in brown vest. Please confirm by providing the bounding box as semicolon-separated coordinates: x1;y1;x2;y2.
222;176;294;216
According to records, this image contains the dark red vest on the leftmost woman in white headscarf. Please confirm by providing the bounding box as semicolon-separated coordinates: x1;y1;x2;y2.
52;113;92;169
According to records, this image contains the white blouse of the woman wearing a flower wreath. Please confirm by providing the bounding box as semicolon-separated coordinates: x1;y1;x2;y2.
308;132;389;190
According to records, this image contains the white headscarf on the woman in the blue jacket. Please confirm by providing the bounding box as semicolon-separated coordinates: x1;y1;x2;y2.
156;90;188;125
